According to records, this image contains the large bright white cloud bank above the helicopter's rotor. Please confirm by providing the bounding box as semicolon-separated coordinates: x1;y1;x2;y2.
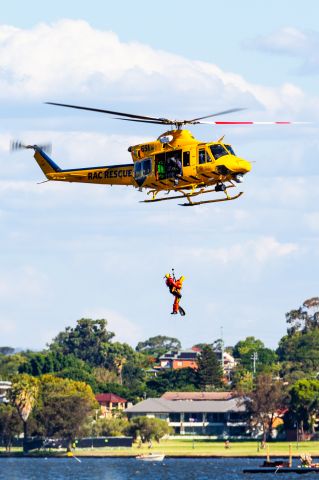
0;20;318;119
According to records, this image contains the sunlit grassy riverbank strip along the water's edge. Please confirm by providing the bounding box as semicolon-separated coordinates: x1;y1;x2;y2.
0;439;319;458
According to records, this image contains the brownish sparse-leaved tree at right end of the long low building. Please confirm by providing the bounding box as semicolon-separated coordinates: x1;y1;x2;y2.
243;373;287;441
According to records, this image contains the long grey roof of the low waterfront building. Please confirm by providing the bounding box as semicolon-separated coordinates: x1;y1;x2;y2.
125;398;246;415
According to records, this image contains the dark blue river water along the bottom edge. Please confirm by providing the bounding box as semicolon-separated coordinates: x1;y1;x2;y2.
0;458;318;480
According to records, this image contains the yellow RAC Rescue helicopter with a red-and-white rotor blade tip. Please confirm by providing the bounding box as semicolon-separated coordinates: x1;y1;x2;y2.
12;102;305;206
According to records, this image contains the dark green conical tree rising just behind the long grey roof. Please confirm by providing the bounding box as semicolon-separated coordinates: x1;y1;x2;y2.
197;345;223;390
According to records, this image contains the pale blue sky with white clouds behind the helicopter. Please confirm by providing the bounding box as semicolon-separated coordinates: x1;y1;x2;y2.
0;0;319;350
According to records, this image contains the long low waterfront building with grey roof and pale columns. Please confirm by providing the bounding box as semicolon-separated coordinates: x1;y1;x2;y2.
125;397;250;439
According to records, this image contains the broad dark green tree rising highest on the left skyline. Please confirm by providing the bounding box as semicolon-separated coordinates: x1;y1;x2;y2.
49;318;114;366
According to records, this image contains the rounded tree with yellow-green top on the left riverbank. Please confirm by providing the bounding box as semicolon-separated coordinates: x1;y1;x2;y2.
35;375;99;450
